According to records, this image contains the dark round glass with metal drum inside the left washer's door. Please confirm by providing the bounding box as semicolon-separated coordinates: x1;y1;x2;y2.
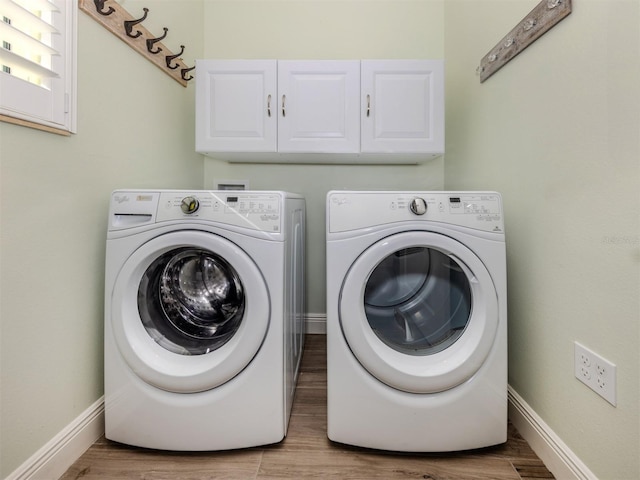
138;248;245;355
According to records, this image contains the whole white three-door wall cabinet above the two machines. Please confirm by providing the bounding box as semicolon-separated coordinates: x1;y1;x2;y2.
196;60;444;163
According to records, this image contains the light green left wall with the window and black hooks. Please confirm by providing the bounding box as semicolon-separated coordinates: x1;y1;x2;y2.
0;1;203;478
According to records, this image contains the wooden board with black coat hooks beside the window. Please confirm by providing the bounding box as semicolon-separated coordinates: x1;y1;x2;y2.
78;0;195;87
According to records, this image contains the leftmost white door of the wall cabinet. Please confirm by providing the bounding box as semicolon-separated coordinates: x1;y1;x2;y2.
196;60;277;153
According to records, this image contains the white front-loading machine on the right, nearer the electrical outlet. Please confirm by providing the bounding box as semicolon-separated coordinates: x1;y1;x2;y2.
327;191;507;452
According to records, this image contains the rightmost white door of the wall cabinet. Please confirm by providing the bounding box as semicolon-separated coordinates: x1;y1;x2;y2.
361;60;444;153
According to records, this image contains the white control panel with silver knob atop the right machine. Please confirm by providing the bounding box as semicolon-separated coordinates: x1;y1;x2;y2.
327;191;504;233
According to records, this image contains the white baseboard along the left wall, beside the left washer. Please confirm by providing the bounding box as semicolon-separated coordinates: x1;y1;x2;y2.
5;397;104;480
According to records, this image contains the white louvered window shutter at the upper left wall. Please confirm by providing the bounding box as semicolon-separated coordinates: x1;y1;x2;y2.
0;0;76;132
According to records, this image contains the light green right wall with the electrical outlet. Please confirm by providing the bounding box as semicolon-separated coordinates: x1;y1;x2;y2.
445;0;640;480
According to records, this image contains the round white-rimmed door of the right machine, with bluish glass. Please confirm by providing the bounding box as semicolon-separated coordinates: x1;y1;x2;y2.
339;231;499;393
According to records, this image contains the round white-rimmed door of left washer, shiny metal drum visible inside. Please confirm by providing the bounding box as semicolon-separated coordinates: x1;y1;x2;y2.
111;230;270;393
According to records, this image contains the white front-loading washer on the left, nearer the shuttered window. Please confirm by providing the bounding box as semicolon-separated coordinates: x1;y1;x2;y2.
104;190;305;451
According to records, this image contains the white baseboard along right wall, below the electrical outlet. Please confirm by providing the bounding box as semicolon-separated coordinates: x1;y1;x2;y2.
508;386;598;480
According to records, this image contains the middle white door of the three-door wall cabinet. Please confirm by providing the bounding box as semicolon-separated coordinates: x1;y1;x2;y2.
278;60;360;153
